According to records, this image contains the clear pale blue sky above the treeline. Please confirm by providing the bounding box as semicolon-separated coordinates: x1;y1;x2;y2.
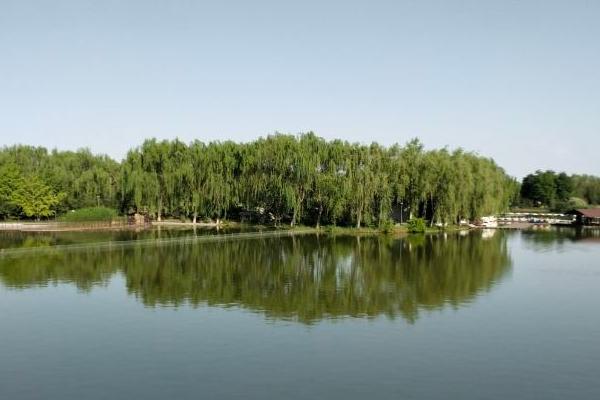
0;0;600;177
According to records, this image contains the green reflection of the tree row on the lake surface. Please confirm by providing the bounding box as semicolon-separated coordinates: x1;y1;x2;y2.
0;233;511;324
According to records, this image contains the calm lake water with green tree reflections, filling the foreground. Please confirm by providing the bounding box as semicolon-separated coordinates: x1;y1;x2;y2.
0;230;600;400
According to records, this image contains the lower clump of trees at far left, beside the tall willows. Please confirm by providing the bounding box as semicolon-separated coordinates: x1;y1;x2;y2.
0;145;121;218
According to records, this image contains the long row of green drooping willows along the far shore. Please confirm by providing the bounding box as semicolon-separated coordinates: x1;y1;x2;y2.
0;133;519;223
